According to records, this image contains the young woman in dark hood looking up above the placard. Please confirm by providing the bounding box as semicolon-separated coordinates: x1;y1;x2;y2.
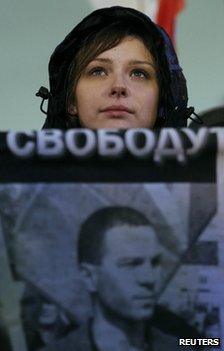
37;6;192;129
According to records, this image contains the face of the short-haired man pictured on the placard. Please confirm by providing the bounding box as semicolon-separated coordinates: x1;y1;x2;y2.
96;225;160;321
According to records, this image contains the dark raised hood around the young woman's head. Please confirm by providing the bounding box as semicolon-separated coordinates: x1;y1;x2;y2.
41;6;188;129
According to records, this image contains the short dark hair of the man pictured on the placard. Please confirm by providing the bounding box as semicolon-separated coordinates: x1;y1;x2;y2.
78;206;151;265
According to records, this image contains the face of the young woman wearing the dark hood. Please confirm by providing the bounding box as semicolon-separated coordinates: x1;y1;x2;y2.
69;37;159;129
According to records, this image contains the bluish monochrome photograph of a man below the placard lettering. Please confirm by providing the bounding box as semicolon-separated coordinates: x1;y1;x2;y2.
0;183;224;351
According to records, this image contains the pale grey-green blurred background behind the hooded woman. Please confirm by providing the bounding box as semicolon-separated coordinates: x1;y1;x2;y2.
0;0;224;130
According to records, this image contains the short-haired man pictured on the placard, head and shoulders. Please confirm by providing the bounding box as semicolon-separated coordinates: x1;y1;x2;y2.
38;206;200;351
